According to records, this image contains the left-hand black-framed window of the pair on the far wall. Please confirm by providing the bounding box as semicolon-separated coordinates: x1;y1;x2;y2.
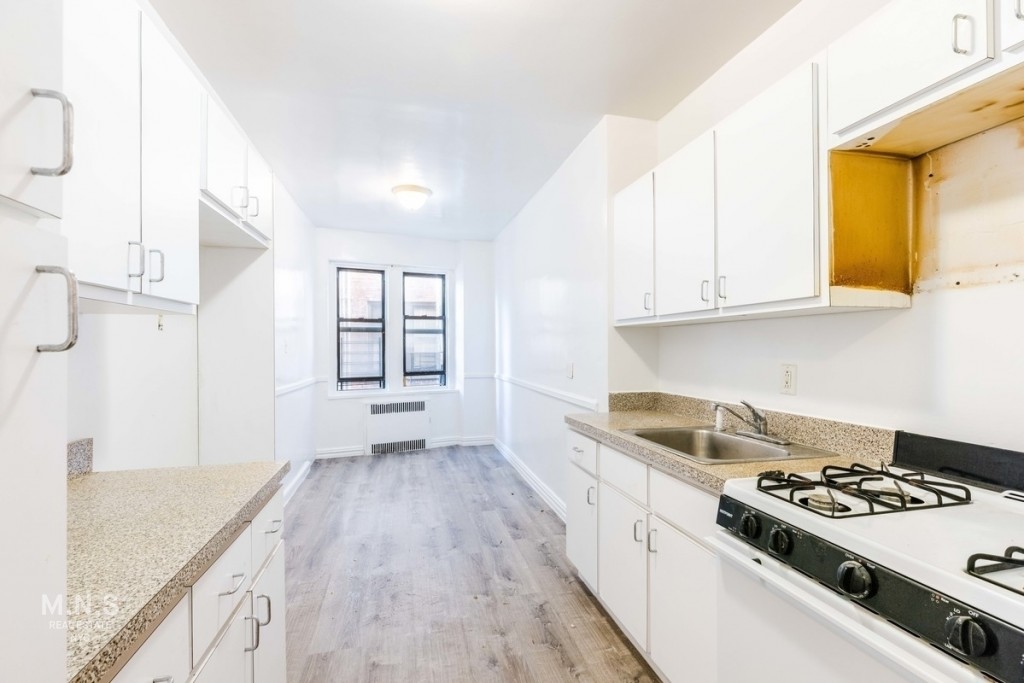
338;268;384;391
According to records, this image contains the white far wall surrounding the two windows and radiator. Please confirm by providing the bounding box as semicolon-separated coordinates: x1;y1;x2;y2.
313;228;495;457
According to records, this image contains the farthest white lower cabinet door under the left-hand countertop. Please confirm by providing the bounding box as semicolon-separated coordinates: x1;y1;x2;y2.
252;542;288;683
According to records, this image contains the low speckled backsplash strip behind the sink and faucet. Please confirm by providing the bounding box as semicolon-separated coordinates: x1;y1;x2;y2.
608;391;896;464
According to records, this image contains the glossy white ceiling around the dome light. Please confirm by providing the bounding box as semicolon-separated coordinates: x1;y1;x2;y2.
151;0;797;240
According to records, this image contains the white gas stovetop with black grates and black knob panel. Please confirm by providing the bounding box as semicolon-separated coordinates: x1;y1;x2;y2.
718;436;1024;683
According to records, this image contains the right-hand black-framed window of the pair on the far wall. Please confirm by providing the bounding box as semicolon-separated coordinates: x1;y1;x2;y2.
401;272;447;386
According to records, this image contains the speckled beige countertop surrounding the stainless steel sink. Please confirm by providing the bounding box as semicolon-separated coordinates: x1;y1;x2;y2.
565;411;863;495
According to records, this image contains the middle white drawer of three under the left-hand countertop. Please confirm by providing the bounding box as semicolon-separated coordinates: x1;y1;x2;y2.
191;524;253;666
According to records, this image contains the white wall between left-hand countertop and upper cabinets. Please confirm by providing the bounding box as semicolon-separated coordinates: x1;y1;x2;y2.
68;312;199;471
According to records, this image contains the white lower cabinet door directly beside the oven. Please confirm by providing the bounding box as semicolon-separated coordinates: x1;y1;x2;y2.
647;515;718;681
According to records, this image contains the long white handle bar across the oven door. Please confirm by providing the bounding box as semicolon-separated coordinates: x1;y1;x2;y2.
705;530;962;683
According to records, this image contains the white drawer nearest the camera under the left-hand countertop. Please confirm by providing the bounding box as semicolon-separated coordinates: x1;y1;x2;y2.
114;595;191;683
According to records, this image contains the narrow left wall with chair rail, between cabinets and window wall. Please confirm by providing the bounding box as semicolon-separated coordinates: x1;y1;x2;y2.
273;179;316;492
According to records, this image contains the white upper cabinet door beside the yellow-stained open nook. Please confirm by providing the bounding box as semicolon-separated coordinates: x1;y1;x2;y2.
715;65;817;307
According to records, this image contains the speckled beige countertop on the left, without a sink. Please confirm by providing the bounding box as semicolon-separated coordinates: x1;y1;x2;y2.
66;462;289;683
